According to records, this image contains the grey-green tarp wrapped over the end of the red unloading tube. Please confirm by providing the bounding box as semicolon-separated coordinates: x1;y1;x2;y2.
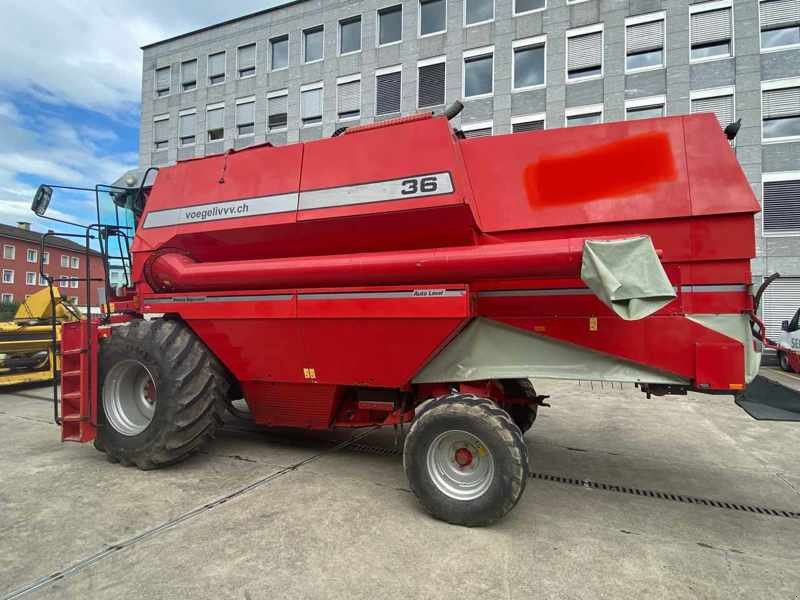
581;235;675;321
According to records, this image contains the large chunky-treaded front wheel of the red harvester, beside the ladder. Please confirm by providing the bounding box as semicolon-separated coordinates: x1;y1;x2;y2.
95;319;229;469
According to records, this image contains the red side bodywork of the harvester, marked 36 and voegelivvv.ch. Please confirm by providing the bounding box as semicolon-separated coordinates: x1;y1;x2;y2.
122;115;758;427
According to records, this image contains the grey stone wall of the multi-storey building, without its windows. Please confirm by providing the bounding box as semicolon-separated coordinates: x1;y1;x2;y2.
140;0;800;308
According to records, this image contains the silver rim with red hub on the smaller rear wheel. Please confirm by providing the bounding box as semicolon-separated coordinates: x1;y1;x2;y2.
426;430;494;501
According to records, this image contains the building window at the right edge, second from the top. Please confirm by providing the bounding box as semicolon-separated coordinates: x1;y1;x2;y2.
761;77;800;142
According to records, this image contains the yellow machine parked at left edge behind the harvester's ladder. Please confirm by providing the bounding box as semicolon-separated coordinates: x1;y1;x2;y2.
0;287;81;386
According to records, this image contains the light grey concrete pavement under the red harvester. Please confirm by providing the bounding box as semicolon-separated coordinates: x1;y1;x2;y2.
0;382;800;600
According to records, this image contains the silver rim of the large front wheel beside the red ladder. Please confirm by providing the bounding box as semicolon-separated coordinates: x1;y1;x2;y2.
103;359;157;436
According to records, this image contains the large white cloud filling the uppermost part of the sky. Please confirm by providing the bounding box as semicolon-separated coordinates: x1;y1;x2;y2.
0;0;286;114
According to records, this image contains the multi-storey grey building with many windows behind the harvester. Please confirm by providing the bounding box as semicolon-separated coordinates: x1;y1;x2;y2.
140;0;800;333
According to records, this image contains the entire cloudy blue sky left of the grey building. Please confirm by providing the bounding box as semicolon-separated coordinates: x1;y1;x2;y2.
0;0;282;231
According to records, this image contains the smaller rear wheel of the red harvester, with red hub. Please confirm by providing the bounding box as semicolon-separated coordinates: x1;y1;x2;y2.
403;394;528;527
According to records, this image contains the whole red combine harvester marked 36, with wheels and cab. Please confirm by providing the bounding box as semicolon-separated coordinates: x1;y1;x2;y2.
33;107;760;525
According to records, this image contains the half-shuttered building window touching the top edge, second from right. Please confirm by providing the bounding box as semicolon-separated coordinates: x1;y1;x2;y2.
689;0;733;61
